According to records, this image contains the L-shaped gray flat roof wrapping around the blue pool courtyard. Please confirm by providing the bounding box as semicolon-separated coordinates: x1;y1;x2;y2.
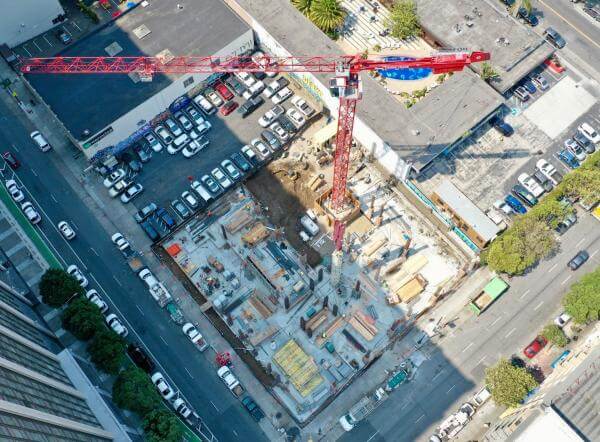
226;0;502;171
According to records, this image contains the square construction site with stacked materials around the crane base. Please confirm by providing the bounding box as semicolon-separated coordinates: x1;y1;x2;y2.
162;118;463;423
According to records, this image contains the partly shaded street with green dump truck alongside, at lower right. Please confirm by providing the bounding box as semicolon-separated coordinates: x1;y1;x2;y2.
340;214;600;442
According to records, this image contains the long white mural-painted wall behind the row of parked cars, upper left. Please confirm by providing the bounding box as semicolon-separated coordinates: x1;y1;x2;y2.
82;29;254;158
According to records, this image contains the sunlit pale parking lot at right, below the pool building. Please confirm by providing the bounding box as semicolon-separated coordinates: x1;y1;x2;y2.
418;66;600;216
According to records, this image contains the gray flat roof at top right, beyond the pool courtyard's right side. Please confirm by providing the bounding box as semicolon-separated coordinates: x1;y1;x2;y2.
417;0;554;93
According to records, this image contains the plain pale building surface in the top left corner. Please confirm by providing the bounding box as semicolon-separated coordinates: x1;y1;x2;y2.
0;0;64;48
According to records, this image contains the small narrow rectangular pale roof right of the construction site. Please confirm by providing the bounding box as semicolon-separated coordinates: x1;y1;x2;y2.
434;178;500;242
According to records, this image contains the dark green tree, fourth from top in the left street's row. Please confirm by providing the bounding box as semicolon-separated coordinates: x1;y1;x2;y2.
113;365;161;416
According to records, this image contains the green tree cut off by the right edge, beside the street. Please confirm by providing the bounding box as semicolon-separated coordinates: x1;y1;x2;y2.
563;268;600;324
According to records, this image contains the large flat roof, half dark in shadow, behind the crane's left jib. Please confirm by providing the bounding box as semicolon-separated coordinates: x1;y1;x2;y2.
28;0;249;138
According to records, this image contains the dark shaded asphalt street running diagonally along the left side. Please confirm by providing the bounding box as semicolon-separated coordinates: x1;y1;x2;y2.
0;95;268;441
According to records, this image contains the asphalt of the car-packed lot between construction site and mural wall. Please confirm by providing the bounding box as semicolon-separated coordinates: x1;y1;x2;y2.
98;72;317;235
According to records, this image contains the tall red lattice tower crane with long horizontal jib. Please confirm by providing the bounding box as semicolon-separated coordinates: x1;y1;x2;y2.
21;51;490;272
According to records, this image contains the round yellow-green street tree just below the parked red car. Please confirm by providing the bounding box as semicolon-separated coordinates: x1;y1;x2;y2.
485;359;538;407
